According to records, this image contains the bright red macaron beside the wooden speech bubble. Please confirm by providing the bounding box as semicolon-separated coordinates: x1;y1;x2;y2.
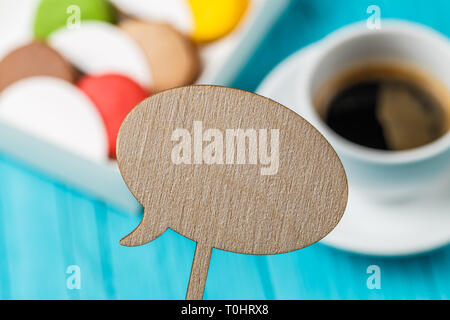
77;74;150;159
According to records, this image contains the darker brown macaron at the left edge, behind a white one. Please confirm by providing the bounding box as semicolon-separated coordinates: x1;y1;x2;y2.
0;42;77;91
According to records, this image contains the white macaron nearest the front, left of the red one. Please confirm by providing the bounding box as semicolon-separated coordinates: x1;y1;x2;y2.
0;77;108;162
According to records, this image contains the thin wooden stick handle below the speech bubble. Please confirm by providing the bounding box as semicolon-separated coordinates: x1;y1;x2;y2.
186;242;212;300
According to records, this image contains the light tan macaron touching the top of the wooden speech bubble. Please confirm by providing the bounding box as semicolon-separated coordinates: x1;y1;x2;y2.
119;20;200;92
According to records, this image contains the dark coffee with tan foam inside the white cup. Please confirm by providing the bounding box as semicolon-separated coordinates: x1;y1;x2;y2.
316;66;450;150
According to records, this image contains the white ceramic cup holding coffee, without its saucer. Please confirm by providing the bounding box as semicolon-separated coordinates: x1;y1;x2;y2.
297;21;450;201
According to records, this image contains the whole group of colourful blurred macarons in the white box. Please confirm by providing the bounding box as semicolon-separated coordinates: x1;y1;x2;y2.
0;0;249;161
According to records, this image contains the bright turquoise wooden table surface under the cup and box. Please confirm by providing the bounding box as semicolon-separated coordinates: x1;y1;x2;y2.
0;0;450;299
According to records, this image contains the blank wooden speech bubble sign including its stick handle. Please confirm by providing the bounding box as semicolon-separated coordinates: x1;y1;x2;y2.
117;86;348;299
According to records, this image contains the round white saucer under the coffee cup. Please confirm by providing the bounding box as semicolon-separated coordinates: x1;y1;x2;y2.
258;43;450;256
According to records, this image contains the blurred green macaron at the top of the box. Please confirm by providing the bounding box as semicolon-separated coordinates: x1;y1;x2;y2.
34;0;116;40
